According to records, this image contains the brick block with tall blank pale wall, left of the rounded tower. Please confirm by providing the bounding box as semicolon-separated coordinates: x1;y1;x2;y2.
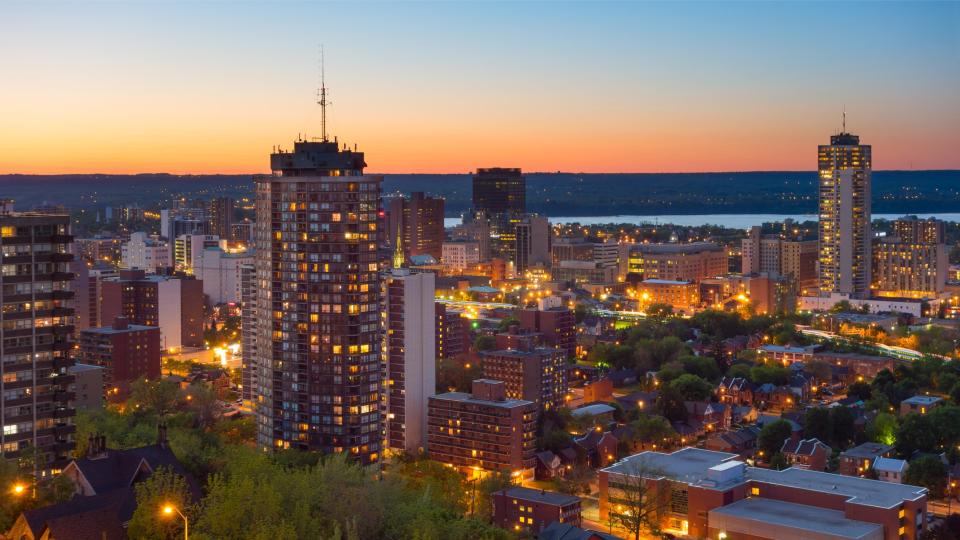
100;270;204;350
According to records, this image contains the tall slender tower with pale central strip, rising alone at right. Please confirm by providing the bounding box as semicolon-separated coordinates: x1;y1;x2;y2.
818;133;873;298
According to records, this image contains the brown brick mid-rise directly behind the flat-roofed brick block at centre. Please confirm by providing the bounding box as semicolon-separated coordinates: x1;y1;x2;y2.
481;347;567;409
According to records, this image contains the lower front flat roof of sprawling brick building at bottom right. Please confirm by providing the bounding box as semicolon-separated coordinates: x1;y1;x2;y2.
709;497;883;539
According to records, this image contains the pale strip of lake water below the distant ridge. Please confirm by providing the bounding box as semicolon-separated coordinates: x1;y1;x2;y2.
443;213;960;229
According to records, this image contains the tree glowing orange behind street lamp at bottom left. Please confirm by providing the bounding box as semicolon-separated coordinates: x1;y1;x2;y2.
127;467;195;539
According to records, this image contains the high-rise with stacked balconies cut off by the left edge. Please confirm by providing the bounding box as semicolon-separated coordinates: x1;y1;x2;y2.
0;211;76;476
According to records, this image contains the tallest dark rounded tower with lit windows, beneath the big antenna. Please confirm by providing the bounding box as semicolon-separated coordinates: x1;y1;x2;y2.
255;136;383;464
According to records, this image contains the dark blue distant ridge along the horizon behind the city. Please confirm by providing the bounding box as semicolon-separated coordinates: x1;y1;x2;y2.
0;170;960;216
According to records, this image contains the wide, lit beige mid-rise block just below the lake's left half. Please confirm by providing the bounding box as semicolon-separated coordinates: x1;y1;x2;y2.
627;242;727;283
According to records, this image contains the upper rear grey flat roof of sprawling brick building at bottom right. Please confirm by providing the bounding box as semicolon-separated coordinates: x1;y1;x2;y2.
603;447;927;508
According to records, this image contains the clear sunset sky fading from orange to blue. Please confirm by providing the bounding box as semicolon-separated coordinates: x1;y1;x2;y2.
0;0;960;174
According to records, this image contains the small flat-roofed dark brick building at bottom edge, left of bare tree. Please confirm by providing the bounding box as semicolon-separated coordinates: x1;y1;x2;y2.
492;487;581;534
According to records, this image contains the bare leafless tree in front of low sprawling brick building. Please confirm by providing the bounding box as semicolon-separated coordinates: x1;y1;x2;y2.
607;459;673;540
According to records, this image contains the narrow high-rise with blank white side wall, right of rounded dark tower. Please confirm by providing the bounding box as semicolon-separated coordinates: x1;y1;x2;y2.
383;268;437;453
